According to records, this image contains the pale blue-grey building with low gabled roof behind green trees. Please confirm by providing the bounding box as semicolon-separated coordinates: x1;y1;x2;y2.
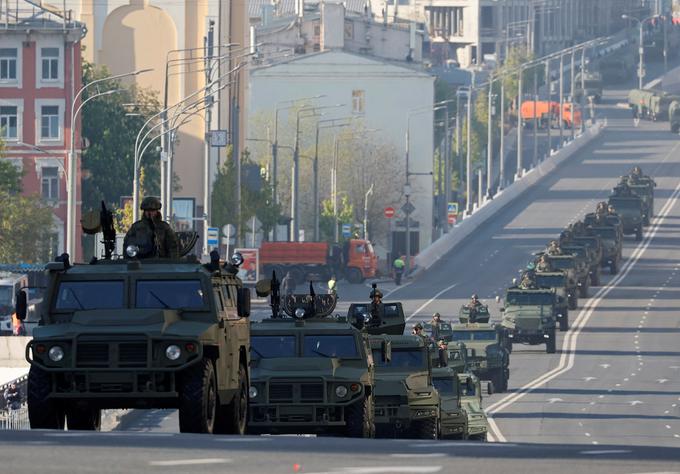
247;3;434;254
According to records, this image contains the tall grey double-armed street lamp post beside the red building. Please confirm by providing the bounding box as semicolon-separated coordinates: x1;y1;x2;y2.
66;69;153;260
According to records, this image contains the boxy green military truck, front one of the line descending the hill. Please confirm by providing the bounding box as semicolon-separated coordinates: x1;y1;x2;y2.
501;286;557;354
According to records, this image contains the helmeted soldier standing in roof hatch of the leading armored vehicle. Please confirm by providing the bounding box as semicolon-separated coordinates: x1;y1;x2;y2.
123;196;179;258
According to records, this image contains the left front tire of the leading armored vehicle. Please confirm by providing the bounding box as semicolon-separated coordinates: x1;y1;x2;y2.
26;365;65;430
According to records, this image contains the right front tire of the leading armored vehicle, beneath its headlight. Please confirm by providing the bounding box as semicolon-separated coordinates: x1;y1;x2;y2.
179;358;218;433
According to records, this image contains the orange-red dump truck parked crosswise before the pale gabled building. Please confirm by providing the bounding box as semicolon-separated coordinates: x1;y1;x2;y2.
260;239;378;283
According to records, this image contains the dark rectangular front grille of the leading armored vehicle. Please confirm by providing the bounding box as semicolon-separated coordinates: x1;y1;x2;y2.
76;341;148;368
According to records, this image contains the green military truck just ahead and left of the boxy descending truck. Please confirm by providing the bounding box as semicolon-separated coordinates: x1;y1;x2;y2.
452;319;510;392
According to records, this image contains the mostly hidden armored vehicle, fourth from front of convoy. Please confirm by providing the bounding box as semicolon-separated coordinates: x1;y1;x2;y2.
432;367;469;439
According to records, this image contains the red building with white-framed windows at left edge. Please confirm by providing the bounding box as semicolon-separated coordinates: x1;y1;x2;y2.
0;0;87;259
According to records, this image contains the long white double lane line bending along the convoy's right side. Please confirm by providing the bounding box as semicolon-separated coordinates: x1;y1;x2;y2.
487;168;680;442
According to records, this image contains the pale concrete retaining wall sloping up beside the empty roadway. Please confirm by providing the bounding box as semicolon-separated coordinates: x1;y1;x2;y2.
414;123;606;276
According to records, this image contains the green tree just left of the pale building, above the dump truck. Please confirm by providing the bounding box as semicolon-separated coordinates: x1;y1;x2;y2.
210;150;281;239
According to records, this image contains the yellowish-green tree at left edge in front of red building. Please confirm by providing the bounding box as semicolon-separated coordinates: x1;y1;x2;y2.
0;141;54;263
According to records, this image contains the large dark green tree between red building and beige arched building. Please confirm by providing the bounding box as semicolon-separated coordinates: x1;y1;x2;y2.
81;62;160;213
